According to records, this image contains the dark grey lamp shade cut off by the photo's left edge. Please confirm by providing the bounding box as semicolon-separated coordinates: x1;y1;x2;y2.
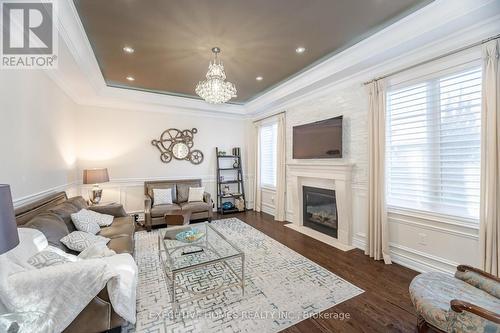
0;184;19;254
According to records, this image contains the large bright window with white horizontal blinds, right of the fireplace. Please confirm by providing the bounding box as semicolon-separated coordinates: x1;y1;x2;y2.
386;67;481;220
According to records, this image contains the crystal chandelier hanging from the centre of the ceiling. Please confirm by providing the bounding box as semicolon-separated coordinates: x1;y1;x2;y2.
195;47;236;104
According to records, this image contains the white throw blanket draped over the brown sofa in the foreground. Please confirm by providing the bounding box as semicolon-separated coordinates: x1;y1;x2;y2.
0;250;137;332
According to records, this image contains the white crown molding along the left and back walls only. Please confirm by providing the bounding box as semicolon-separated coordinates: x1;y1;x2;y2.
50;1;245;116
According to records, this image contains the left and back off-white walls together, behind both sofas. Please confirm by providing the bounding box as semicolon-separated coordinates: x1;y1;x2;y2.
0;66;252;211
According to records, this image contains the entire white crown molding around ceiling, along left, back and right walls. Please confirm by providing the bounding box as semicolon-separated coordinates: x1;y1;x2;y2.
46;0;500;119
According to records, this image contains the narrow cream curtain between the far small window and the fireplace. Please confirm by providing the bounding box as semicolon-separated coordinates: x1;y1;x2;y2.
274;113;286;221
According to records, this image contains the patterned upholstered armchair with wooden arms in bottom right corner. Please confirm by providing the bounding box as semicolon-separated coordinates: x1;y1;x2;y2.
410;265;500;333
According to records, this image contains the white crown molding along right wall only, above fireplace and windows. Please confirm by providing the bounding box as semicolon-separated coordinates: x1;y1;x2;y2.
245;0;500;119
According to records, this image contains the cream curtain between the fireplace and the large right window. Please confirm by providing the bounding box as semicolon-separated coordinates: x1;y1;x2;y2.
365;80;391;264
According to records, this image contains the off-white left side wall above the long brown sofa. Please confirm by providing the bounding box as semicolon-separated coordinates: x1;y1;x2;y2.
0;70;78;205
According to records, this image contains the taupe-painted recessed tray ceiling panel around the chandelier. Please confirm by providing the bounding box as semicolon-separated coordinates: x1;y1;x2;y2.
75;0;431;103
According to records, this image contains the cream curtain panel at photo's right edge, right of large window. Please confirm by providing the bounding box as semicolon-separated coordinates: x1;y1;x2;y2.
480;39;500;276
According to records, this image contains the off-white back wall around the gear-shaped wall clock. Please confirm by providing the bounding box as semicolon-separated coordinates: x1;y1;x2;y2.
76;106;249;211
